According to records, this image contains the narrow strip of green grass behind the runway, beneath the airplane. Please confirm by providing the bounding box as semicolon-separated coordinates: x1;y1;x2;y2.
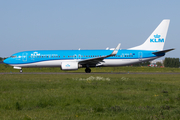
0;64;180;72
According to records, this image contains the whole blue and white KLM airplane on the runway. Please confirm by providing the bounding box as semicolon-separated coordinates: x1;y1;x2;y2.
4;19;174;73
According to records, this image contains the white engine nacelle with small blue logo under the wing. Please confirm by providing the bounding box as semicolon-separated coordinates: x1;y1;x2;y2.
61;62;78;70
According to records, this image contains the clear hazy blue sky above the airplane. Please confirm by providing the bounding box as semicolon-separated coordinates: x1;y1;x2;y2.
0;0;180;58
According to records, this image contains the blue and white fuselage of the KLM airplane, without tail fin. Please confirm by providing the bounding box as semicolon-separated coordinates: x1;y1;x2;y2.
4;50;164;67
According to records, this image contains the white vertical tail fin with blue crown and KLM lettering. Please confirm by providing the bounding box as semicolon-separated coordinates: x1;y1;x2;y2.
129;19;170;50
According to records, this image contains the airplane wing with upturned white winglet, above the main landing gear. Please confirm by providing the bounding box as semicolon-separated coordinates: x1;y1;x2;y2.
79;43;121;64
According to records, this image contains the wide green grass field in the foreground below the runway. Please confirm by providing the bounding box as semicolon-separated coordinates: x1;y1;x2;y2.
0;74;180;120
